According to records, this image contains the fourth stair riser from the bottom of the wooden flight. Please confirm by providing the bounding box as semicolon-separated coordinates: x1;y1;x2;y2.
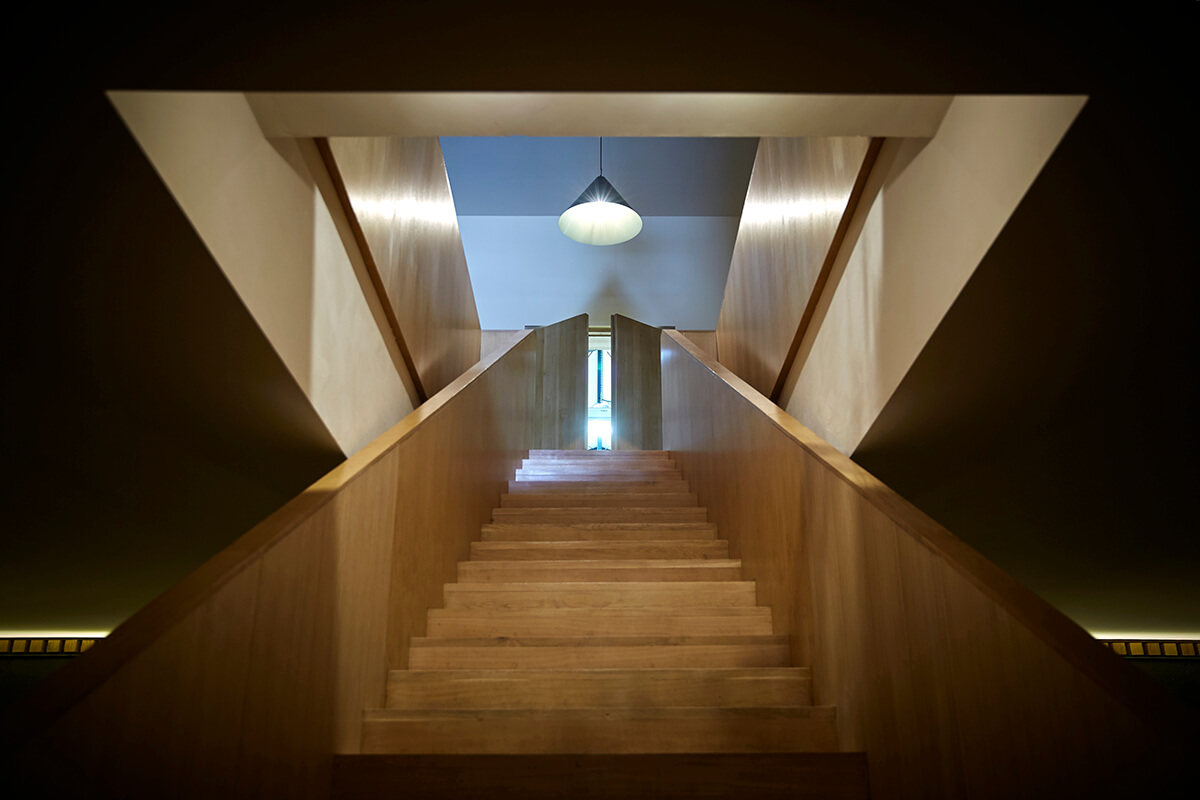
408;644;792;669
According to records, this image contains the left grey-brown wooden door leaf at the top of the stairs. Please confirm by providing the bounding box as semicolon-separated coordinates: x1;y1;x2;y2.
534;314;588;450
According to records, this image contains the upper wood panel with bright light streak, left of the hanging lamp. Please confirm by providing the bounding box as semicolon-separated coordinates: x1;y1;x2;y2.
328;137;480;396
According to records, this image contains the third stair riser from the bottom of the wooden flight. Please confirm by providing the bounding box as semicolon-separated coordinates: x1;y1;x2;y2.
388;669;812;710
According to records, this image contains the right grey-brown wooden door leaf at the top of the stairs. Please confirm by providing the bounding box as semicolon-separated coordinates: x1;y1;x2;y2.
612;314;662;450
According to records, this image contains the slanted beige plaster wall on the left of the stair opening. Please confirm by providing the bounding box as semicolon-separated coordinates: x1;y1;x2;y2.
109;92;413;455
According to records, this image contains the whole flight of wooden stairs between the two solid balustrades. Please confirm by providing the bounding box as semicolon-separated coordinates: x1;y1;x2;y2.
337;451;865;796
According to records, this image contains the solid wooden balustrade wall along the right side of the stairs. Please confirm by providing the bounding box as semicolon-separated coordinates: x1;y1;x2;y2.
661;331;1196;798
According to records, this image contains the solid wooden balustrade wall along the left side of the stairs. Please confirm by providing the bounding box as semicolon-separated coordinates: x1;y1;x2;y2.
0;333;536;799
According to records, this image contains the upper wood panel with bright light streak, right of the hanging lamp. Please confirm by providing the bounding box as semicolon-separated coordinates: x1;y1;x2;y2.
716;137;870;396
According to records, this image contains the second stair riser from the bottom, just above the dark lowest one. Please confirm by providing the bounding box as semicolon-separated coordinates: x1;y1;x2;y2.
362;717;838;753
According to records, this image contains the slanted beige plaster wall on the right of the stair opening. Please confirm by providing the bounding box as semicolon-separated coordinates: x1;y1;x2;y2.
782;97;1085;455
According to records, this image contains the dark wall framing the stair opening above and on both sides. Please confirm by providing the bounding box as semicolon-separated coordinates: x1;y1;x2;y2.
0;1;1198;652
